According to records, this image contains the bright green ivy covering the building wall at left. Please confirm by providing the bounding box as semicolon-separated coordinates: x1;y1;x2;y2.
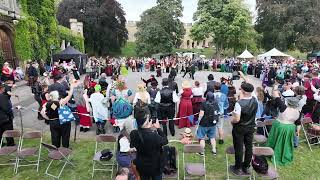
15;0;84;61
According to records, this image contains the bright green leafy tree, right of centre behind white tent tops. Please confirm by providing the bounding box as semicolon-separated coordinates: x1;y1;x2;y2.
191;0;258;56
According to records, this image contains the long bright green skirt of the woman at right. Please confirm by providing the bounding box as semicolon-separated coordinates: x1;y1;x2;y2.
267;120;296;165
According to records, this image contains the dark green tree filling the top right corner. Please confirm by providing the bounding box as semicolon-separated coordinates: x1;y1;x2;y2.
255;0;320;52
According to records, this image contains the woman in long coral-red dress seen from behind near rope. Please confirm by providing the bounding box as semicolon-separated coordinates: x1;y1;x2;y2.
178;81;193;129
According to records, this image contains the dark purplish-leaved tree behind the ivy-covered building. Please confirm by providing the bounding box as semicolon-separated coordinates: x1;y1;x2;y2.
57;0;128;55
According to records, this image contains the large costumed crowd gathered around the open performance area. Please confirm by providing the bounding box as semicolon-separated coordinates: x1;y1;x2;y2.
0;54;320;180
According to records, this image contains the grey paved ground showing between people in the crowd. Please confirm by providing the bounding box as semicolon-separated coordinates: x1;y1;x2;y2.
12;71;261;139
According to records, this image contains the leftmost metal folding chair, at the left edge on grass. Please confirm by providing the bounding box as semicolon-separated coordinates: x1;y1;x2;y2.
0;130;21;172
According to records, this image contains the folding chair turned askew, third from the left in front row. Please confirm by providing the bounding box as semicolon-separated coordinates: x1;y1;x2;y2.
41;143;75;179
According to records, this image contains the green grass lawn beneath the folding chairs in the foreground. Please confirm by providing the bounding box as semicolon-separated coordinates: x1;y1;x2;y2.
0;134;320;180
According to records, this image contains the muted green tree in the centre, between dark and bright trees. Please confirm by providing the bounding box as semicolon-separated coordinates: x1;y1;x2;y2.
135;0;185;56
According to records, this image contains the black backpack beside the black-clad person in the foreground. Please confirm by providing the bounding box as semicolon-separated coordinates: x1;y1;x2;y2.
163;146;177;175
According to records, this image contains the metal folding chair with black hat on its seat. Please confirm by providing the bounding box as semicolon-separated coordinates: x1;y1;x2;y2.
92;134;117;179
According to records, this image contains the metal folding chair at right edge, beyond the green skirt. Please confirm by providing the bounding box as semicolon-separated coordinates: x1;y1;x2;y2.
300;118;320;151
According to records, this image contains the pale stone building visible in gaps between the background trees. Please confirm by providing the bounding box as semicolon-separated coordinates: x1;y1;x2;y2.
126;21;212;49
